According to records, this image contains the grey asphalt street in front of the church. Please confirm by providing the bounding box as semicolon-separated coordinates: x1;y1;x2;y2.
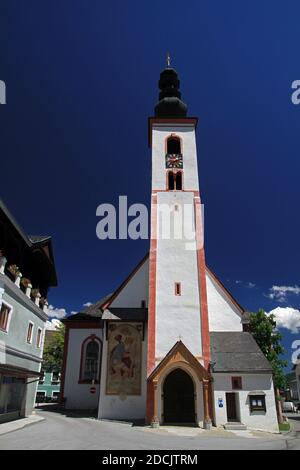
0;410;300;450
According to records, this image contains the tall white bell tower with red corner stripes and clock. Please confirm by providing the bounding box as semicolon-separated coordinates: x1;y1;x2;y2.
147;57;210;382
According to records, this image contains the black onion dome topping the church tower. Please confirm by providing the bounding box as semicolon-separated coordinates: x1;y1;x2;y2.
154;67;187;117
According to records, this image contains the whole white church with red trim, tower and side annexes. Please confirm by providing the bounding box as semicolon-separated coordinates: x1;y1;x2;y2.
61;60;278;432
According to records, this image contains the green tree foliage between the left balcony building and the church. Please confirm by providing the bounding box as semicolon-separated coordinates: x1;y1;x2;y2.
43;325;65;371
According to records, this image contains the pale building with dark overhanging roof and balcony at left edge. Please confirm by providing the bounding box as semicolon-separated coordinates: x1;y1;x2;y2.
0;202;56;423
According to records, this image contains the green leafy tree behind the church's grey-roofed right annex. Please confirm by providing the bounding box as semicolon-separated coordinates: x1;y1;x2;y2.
250;309;287;389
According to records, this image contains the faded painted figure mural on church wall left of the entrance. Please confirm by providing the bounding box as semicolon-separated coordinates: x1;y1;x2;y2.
106;322;143;395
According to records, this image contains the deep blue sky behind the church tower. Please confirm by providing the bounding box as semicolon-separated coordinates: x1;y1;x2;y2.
0;0;300;370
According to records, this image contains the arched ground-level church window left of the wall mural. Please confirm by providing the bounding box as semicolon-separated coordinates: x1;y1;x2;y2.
79;335;102;383
